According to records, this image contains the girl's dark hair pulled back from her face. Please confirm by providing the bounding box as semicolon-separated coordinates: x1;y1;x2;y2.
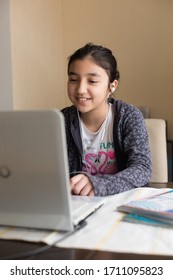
67;43;120;83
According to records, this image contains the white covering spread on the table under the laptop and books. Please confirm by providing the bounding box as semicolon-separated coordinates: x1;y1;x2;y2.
0;188;173;255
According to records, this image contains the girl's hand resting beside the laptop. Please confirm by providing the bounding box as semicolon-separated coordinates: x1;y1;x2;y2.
70;174;94;196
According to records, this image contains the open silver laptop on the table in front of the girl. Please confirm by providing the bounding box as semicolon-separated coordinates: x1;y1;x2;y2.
0;110;104;231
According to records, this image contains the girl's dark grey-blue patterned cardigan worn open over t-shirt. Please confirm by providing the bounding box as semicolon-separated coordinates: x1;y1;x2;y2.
62;98;152;196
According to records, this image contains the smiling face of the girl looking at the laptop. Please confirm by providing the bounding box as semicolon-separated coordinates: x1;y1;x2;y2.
68;57;110;114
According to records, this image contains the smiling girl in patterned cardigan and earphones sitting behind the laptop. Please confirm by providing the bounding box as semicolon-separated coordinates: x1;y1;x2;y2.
62;43;151;196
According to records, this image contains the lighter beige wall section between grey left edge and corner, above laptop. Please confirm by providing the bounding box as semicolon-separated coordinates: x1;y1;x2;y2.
10;0;66;109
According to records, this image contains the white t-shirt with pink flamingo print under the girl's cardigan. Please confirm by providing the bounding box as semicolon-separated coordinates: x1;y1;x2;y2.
79;104;117;175
